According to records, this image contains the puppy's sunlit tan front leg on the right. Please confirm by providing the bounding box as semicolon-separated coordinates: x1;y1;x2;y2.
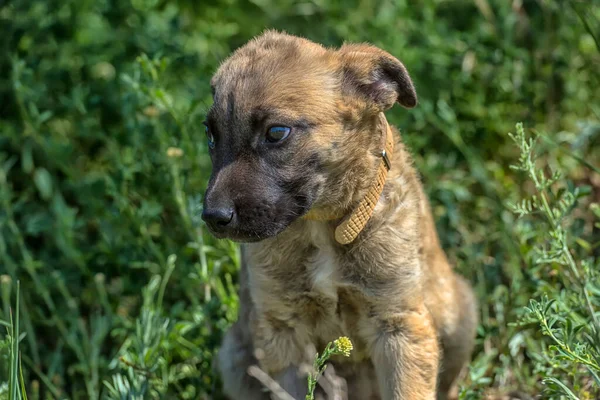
372;306;439;400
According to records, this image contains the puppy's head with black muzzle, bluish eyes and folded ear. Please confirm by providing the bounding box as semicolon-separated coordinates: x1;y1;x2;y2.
203;32;417;241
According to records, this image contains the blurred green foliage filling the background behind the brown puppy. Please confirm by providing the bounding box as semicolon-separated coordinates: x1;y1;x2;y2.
0;0;600;399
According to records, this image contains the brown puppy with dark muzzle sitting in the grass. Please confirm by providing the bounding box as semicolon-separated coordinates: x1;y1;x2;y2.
203;31;476;400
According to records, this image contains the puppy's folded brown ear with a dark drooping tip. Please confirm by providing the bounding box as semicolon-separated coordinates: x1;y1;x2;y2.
338;44;417;111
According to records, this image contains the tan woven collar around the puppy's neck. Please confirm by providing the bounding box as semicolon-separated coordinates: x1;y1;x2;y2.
304;114;394;244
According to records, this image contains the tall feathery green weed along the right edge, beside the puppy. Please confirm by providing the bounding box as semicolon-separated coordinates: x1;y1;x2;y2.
510;124;600;399
